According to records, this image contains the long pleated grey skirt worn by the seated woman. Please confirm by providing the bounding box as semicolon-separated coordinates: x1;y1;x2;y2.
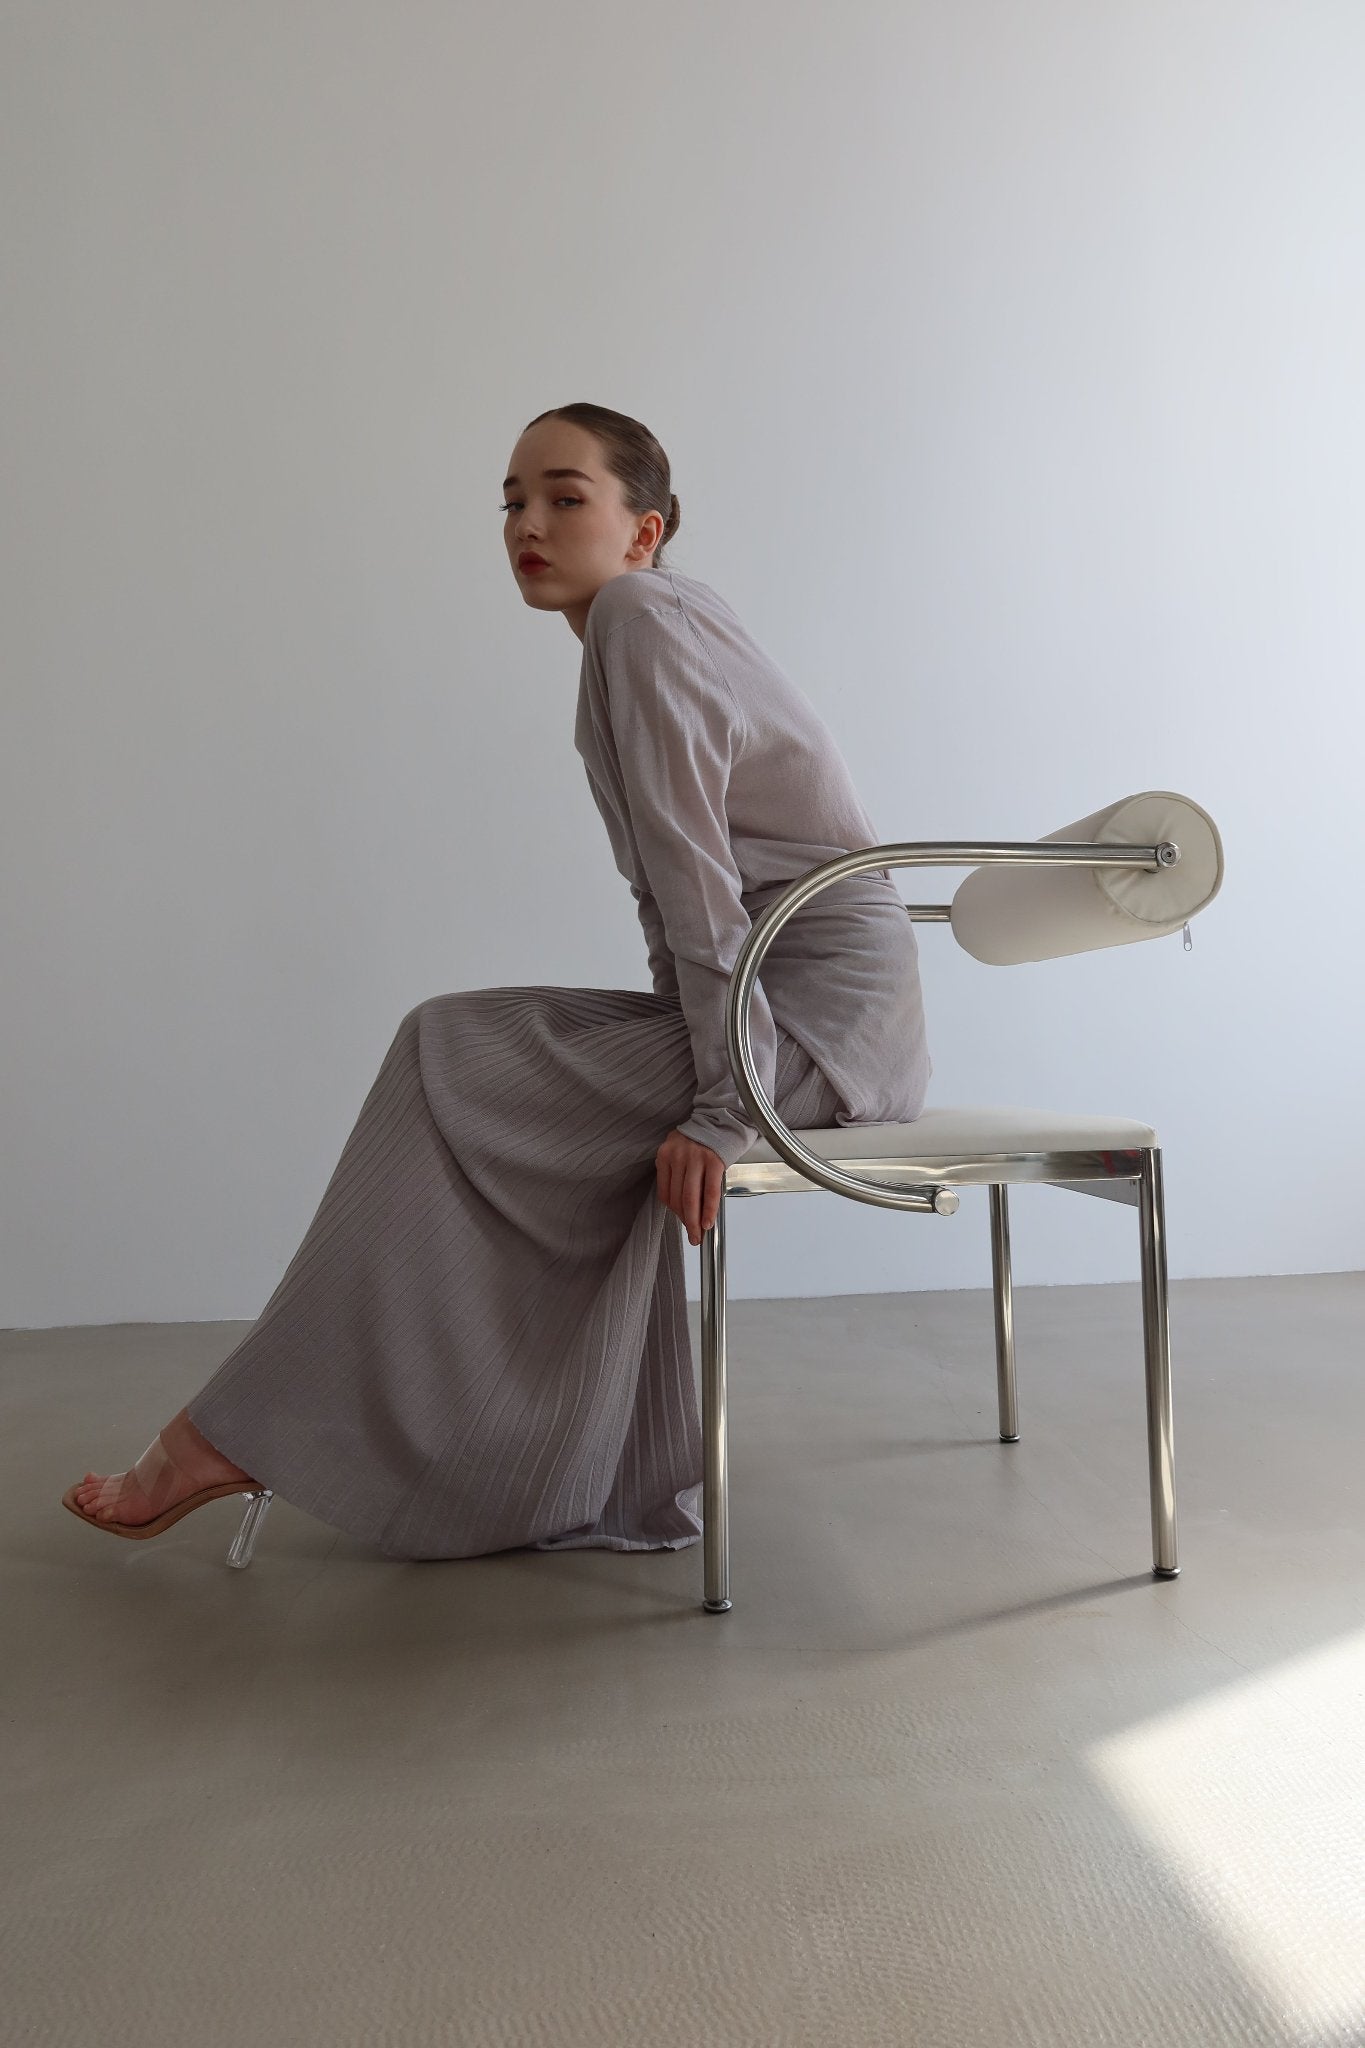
186;987;839;1559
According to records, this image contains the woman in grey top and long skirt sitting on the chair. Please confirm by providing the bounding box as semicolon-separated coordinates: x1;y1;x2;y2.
65;403;929;1559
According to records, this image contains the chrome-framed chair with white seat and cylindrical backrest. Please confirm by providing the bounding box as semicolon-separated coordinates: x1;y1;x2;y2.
702;791;1222;1614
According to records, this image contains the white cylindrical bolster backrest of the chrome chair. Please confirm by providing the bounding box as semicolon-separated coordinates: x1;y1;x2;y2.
952;788;1224;967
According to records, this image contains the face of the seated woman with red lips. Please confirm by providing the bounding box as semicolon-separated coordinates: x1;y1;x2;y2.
503;420;663;639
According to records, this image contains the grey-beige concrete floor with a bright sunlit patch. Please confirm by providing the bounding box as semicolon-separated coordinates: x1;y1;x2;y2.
0;1274;1365;2048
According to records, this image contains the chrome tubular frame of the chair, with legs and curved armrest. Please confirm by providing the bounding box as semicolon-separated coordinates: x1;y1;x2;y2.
702;840;1181;1614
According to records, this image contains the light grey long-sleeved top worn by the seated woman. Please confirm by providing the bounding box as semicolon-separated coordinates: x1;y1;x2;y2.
573;569;929;1165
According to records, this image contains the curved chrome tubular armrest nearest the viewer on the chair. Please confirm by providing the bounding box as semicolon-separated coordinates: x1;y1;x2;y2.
724;840;1181;1217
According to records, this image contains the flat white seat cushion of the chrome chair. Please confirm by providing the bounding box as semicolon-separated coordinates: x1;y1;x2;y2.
737;1108;1156;1165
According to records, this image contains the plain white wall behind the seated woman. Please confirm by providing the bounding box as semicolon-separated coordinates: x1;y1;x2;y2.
0;0;1365;1327
